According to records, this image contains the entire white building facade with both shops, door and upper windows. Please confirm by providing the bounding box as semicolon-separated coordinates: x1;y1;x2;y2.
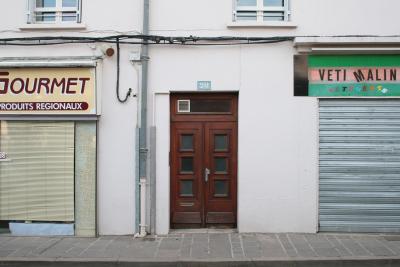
0;0;400;235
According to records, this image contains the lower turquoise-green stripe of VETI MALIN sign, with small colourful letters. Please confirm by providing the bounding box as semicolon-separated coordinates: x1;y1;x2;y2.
308;83;400;96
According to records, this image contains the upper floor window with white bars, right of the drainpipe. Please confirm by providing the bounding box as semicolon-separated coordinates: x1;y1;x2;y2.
233;0;290;22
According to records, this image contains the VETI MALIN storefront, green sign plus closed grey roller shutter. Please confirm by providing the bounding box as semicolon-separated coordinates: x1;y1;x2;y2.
296;55;400;232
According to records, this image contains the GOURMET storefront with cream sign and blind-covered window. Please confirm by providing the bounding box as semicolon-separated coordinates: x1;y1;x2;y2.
0;64;98;236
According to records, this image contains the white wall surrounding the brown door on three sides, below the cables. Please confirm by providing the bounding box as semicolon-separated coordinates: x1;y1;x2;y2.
150;43;318;234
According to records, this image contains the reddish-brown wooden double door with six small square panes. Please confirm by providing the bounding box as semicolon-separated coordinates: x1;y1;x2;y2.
170;93;237;228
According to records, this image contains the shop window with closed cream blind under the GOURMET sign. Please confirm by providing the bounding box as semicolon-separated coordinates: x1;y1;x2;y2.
0;121;74;222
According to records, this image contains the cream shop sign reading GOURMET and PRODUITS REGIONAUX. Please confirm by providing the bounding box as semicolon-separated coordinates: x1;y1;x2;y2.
0;68;96;115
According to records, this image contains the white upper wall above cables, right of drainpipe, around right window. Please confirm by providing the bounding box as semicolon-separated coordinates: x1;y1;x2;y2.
150;0;400;36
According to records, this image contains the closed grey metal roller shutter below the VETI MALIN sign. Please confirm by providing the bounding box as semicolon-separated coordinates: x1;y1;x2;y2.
319;99;400;232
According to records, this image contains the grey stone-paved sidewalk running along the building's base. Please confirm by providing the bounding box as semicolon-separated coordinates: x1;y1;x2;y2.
0;230;400;266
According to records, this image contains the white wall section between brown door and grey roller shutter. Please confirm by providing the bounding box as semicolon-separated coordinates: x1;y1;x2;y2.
238;43;318;232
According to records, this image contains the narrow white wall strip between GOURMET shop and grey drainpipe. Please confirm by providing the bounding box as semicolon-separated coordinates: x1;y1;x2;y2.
98;49;138;235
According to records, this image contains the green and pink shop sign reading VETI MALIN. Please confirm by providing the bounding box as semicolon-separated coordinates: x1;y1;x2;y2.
308;55;400;96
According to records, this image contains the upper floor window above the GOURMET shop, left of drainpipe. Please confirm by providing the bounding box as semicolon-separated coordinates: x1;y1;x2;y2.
28;0;81;23
